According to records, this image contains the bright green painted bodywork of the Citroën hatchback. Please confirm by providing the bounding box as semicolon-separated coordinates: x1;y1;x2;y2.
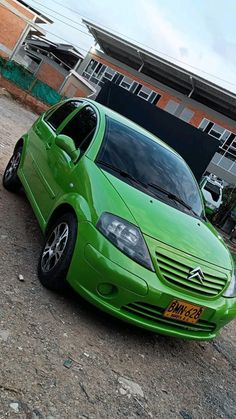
15;100;236;340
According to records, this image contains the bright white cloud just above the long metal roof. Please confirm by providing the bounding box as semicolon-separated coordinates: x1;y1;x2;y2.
127;0;236;91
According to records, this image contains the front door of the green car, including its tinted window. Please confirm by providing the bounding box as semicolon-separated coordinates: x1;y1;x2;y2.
45;104;98;213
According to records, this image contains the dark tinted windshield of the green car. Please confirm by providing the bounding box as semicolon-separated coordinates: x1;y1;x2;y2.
97;117;203;216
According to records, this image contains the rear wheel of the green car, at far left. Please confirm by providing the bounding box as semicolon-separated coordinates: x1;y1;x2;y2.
2;146;22;192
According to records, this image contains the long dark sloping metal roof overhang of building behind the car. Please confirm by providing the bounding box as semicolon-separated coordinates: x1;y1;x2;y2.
83;19;236;120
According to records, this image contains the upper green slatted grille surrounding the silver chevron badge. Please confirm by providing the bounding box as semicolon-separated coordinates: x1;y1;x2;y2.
156;250;227;297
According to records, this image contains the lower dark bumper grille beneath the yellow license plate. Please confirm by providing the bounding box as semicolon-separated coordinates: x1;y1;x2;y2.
122;302;216;333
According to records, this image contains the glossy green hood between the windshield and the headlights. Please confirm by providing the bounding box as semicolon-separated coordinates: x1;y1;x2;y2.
104;171;232;269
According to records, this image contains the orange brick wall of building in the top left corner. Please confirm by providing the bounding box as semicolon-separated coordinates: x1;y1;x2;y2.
0;0;35;57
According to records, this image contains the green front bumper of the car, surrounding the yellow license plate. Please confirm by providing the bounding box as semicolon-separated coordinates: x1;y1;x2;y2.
67;222;236;340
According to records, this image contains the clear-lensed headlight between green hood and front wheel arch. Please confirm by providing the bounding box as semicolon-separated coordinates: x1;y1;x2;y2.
97;212;154;271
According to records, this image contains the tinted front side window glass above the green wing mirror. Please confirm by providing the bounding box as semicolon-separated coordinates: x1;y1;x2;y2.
61;106;97;152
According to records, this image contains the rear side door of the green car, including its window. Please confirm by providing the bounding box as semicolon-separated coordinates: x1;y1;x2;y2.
24;100;83;221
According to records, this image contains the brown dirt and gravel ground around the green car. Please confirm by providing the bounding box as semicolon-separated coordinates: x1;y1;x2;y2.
0;97;236;419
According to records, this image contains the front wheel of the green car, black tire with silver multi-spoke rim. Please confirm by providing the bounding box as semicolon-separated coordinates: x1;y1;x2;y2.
38;212;78;292
